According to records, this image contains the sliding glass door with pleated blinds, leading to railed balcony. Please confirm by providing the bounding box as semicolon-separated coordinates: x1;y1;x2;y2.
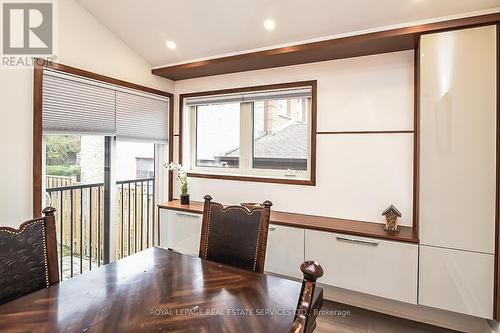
39;68;170;279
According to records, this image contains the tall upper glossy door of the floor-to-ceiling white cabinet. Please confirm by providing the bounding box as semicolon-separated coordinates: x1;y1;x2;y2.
419;26;496;254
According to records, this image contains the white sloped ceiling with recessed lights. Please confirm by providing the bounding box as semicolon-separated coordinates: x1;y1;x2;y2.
77;0;500;66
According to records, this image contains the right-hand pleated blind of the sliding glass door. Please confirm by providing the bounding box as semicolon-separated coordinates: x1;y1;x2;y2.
116;91;169;142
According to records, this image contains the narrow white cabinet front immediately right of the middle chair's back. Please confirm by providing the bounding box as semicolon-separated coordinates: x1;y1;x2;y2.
265;224;304;279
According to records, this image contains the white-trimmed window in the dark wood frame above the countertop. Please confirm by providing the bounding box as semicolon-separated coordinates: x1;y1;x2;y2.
183;84;313;181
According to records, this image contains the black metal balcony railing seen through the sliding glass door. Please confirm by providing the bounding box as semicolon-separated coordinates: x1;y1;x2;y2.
46;178;156;279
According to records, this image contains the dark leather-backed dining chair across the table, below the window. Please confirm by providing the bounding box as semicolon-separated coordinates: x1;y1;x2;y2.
200;195;272;273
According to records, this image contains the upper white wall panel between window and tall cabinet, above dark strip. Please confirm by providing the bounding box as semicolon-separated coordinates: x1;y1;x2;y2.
313;51;414;132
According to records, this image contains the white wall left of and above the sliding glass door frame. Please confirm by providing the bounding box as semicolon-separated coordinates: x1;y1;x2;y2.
0;0;173;226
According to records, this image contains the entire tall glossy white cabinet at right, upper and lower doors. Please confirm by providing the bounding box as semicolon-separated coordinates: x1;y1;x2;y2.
419;26;497;318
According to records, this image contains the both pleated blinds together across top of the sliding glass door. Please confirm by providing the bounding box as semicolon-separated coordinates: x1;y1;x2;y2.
42;70;169;142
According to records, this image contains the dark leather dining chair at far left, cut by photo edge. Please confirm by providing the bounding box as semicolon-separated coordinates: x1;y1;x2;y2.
0;207;59;304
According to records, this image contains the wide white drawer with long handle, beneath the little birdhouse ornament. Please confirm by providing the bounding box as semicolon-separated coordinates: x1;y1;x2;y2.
305;230;418;304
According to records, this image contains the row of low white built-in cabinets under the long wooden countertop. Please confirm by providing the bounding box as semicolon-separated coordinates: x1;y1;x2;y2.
160;209;418;304
